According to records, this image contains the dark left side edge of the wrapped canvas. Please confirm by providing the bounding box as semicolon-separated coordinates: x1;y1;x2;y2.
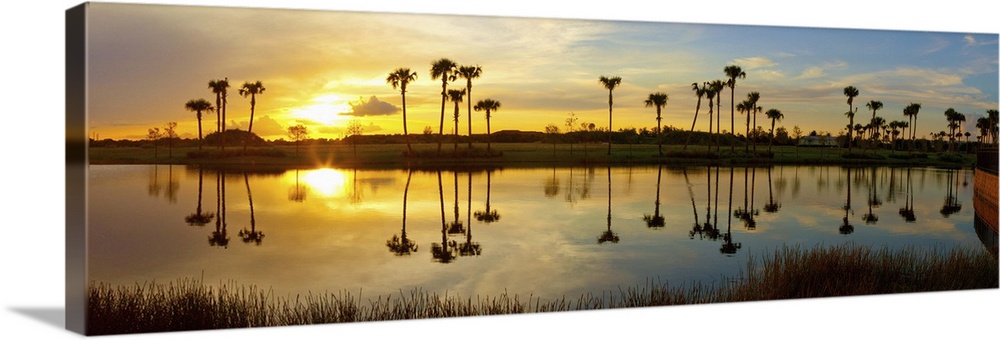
65;3;90;334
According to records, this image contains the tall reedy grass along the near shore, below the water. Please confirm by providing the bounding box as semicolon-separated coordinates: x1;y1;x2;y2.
87;245;1000;334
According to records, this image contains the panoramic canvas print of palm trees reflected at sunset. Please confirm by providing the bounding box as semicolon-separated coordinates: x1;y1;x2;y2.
66;2;998;335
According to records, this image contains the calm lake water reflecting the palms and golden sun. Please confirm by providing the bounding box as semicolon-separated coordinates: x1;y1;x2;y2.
88;165;983;298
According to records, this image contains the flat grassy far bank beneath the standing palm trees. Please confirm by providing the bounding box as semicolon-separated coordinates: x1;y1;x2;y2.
89;143;975;168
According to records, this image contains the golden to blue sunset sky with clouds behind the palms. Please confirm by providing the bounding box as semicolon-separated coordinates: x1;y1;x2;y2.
88;3;998;139
